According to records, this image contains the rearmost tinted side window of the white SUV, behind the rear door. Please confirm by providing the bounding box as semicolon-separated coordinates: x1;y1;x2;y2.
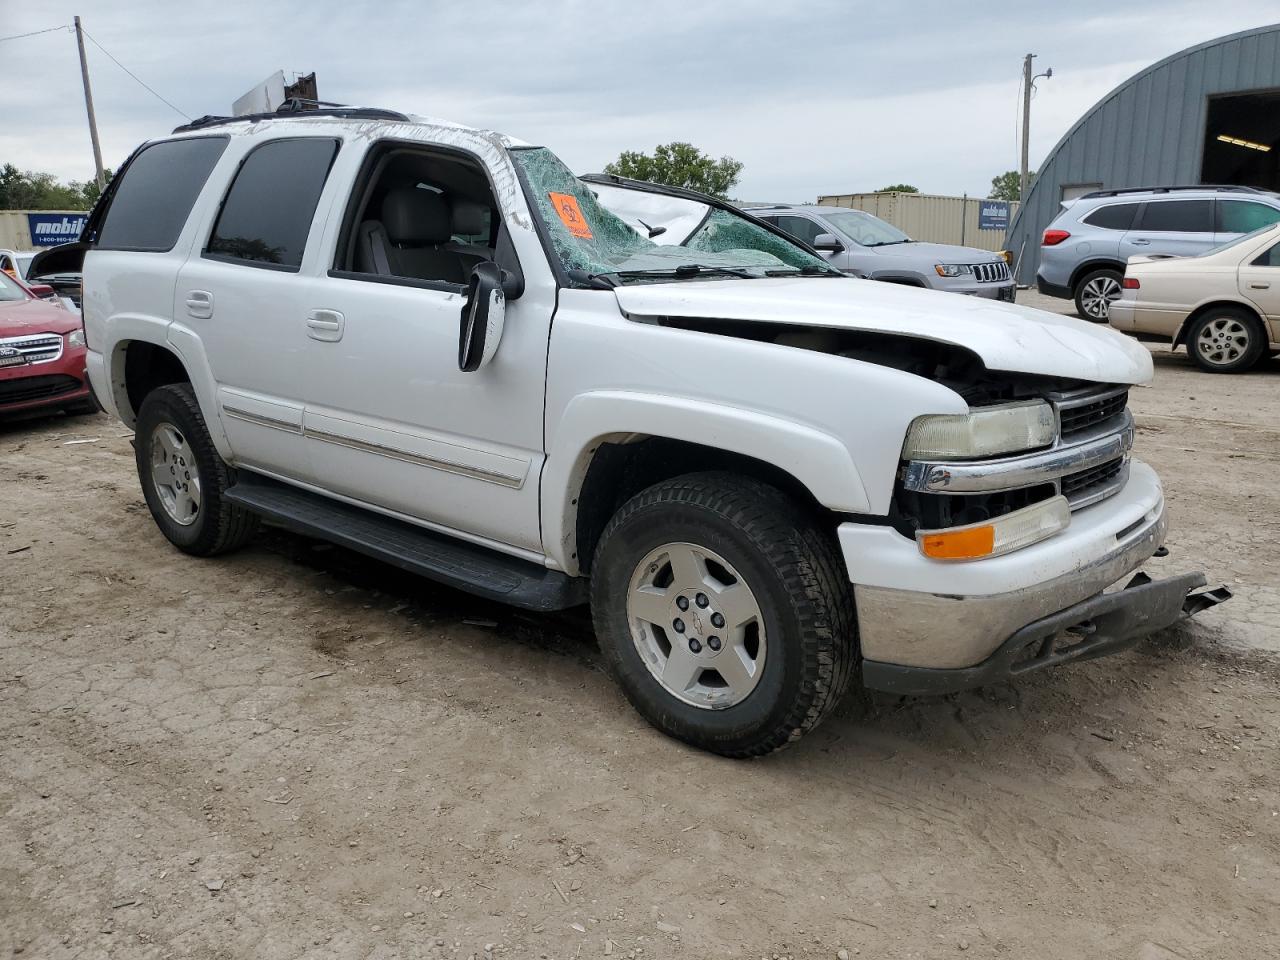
95;137;228;252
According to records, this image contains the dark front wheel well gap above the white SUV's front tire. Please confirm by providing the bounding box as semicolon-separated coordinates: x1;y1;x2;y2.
573;436;837;575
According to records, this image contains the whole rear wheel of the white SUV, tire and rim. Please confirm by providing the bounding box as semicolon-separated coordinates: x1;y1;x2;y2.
133;383;259;557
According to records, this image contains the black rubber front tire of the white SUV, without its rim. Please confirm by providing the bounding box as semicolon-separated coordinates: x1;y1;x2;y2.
591;474;858;758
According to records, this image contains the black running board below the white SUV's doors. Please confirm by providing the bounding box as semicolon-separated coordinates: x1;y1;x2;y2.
225;471;586;611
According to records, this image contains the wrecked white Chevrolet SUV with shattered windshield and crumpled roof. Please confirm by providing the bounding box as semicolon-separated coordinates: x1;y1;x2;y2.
33;108;1226;756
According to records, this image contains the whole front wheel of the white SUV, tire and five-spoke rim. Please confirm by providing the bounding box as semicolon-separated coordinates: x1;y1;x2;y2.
591;474;858;756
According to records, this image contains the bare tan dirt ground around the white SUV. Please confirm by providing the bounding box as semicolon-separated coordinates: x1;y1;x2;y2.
0;321;1280;960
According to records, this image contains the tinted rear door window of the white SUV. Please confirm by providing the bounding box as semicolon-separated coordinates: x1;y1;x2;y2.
205;137;338;270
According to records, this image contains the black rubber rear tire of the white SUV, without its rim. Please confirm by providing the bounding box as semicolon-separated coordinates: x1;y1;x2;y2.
133;383;259;557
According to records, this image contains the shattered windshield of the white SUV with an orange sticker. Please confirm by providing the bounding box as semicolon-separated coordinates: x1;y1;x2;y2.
511;147;838;283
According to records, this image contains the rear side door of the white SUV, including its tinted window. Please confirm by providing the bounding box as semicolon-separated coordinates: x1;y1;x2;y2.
172;134;340;480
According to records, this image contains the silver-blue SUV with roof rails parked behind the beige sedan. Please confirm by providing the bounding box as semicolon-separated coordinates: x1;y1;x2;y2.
1036;186;1280;323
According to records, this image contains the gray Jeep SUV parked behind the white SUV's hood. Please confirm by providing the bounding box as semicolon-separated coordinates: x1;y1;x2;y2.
746;206;1014;303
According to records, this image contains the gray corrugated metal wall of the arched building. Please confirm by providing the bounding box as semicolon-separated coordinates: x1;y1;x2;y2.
1006;23;1280;283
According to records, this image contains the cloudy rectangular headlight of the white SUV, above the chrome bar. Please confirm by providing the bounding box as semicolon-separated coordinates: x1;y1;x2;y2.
902;401;1057;460
